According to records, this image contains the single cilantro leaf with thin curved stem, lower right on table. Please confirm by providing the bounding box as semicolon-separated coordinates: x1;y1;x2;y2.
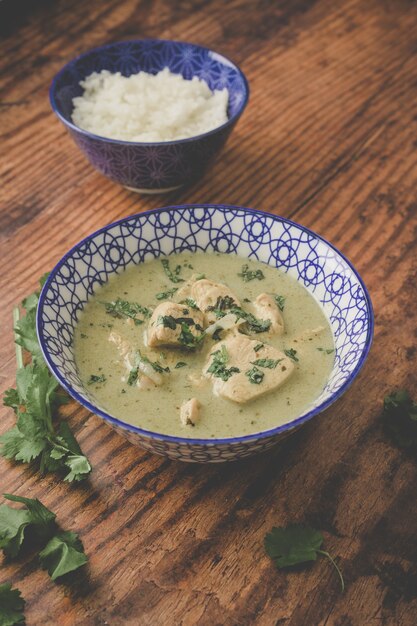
264;525;345;591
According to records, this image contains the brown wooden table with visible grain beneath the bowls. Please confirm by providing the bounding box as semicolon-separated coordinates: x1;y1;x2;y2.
0;0;417;626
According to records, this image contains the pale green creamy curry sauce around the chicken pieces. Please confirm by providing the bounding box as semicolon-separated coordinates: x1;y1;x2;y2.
74;253;334;438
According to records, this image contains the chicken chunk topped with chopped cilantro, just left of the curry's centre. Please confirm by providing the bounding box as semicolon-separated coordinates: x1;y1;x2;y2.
147;302;204;348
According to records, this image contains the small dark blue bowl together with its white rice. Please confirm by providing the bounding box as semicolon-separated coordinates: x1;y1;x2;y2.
50;39;249;193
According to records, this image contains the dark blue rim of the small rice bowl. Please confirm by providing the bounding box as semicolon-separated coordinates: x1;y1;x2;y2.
49;37;250;146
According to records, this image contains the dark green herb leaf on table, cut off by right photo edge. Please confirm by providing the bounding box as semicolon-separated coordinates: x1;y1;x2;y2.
382;389;417;448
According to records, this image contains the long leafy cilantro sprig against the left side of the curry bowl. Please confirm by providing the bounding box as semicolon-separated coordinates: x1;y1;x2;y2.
0;276;91;482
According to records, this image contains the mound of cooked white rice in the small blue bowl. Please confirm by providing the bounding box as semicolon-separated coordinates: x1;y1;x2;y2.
72;68;228;142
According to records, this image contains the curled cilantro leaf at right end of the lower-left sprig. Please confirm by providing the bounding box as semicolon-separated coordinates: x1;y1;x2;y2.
39;531;87;580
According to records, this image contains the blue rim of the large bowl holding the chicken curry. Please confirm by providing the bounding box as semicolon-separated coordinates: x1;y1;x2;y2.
36;203;374;447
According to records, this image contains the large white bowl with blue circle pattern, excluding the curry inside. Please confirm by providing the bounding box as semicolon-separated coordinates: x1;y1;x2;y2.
37;205;373;462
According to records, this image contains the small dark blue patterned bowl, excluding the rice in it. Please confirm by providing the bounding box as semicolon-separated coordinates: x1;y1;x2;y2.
49;39;249;193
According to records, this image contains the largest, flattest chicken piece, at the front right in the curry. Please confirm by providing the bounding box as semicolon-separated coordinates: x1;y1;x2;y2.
203;333;294;404
